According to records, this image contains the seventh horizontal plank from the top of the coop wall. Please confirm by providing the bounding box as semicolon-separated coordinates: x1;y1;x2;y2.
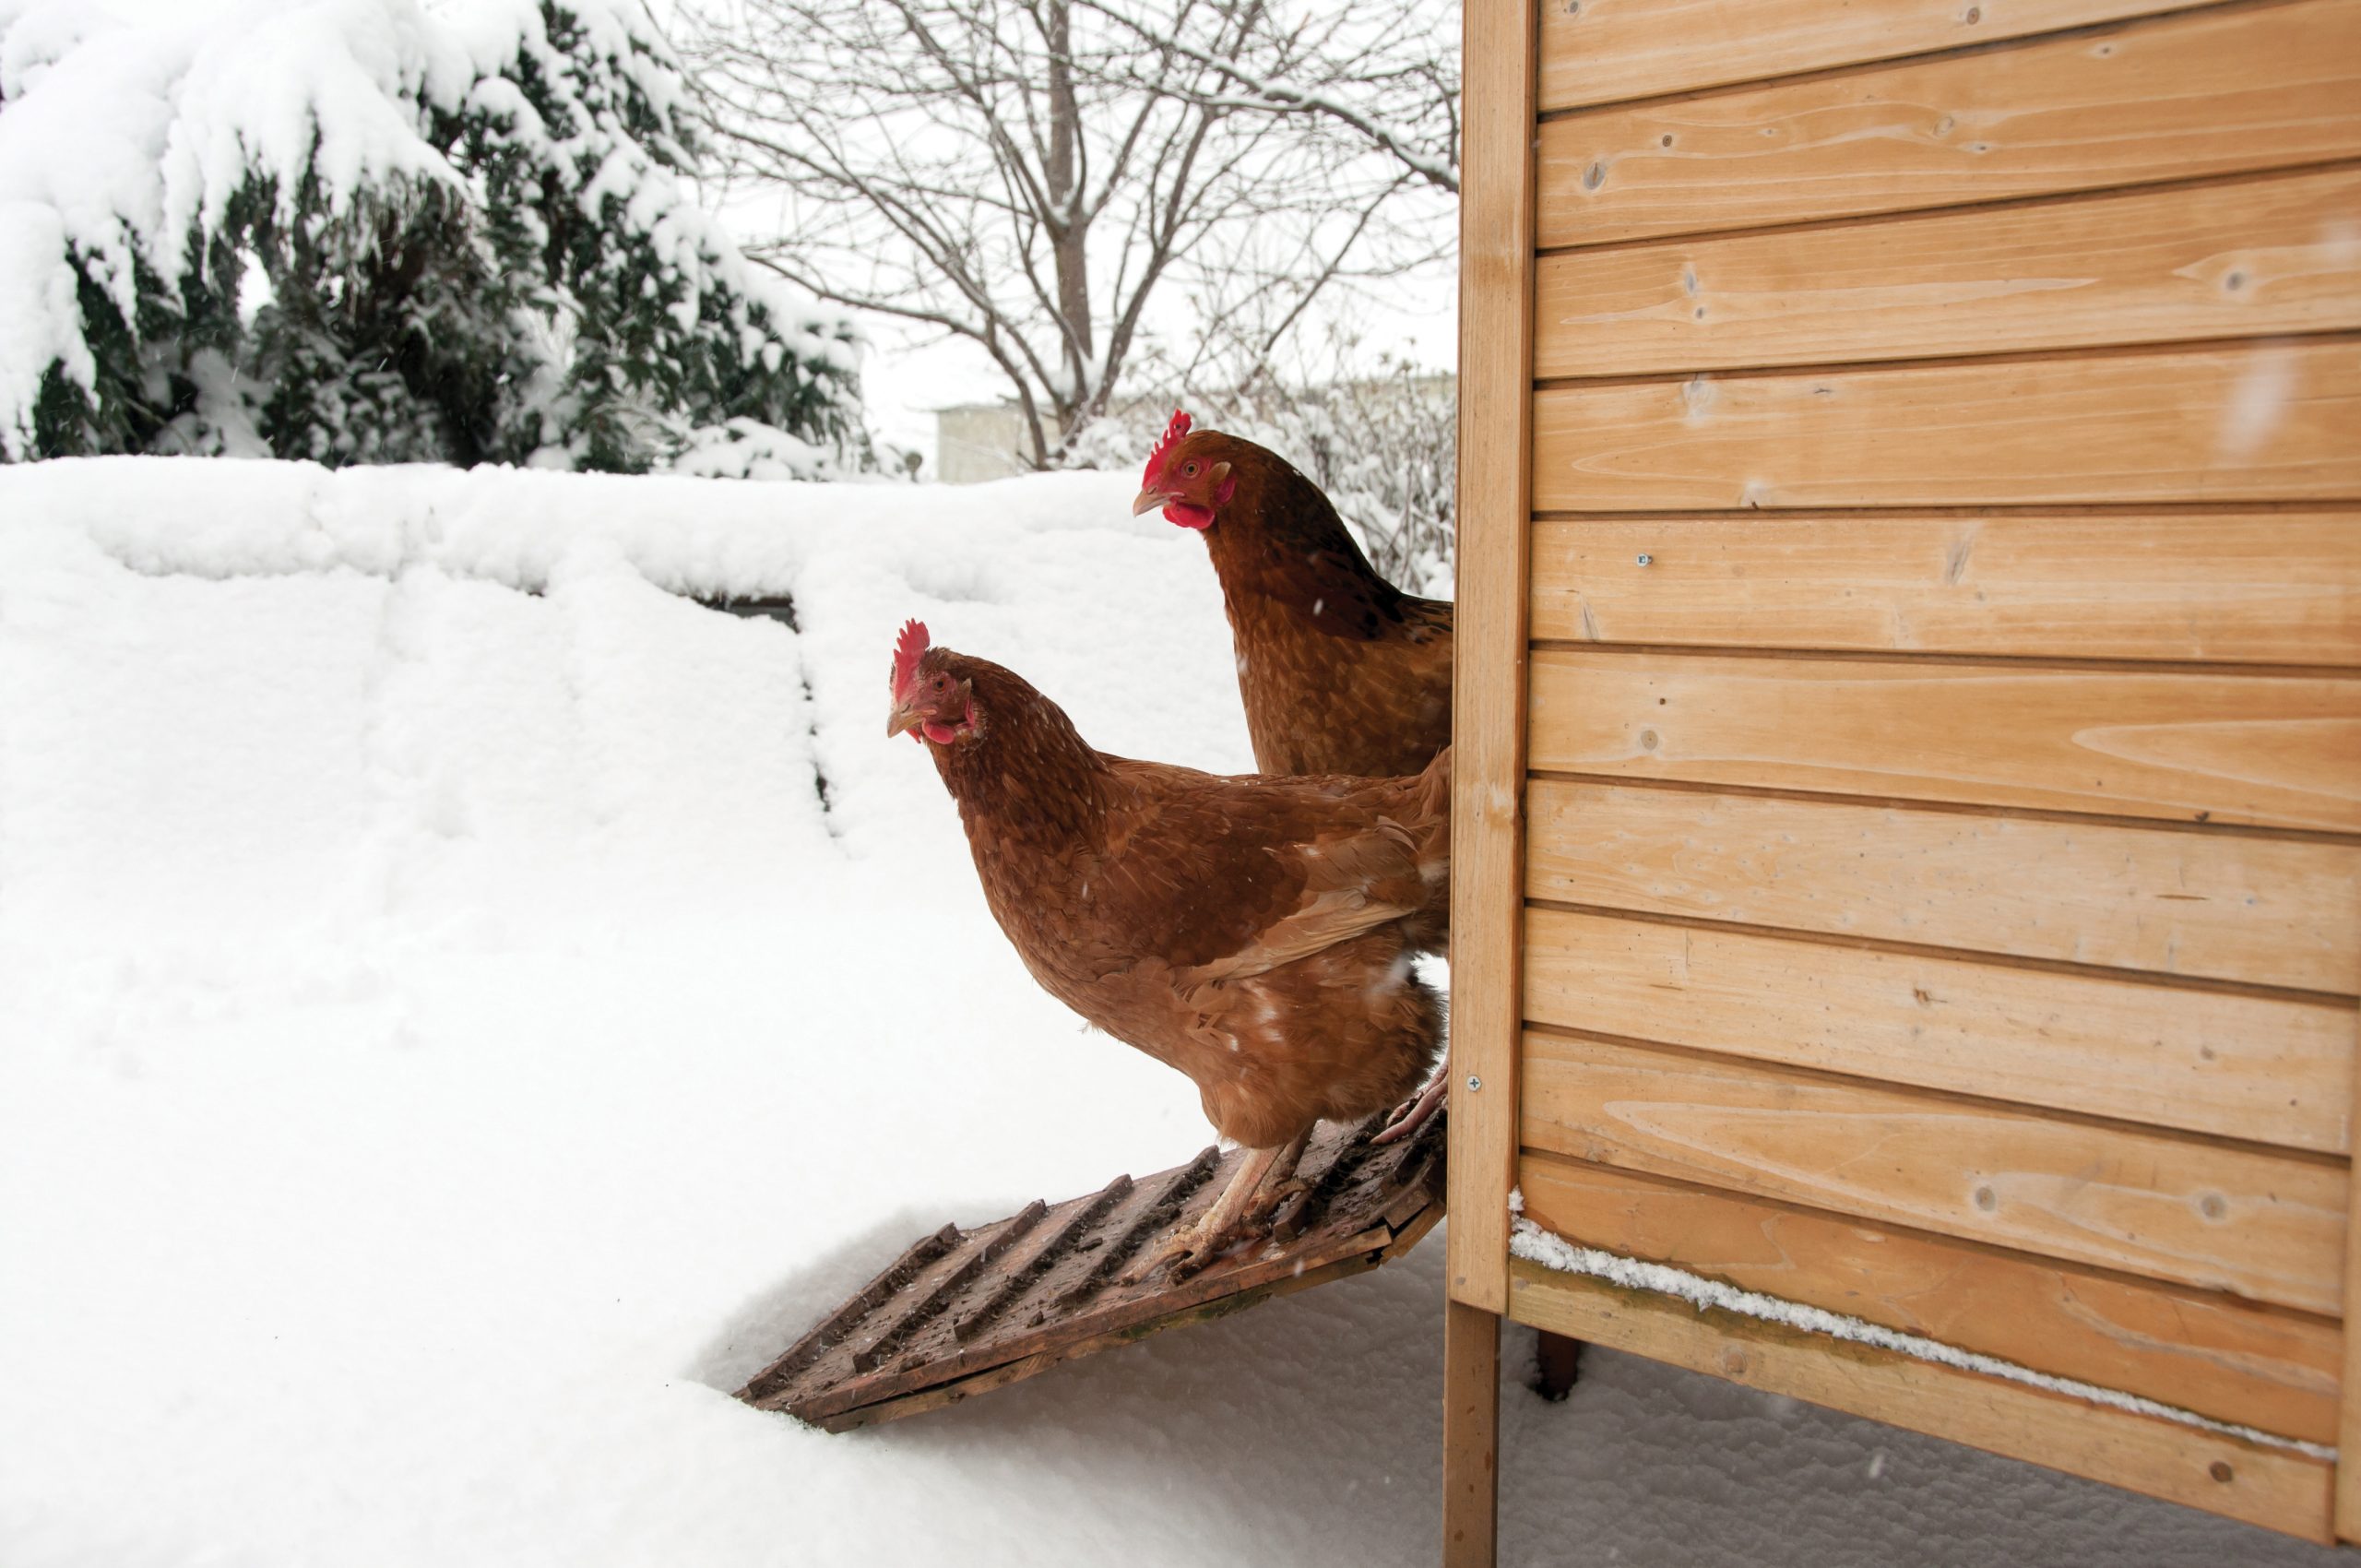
1525;779;2361;994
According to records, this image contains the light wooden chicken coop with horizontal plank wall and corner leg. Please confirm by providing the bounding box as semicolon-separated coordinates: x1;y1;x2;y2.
1445;0;2361;1563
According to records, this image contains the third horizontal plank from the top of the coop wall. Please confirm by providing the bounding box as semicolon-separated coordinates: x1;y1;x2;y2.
1532;170;2361;378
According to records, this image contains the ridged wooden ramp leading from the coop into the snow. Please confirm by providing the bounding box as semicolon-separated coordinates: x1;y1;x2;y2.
737;1114;1442;1431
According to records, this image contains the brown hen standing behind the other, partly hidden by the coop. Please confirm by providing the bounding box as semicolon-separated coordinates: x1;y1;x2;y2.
1131;413;1452;777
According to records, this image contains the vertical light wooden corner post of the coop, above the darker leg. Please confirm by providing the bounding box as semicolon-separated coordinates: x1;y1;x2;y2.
1447;0;1535;1313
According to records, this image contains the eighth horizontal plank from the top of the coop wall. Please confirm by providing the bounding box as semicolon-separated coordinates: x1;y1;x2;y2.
1525;909;2354;1155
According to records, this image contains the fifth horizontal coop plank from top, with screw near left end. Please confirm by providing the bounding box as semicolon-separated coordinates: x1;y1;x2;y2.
1532;513;2361;663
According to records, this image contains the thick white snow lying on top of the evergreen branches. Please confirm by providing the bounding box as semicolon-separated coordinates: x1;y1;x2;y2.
0;0;860;458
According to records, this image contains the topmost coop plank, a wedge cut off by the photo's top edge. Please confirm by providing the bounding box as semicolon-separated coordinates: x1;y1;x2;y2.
1542;0;2191;109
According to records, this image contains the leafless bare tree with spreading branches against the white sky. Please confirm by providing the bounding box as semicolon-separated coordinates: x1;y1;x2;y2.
682;0;1459;465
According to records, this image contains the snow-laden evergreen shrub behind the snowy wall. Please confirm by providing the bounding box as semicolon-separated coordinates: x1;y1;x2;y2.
0;0;861;475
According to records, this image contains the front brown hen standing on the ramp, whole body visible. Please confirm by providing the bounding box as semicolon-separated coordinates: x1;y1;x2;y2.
888;621;1450;1273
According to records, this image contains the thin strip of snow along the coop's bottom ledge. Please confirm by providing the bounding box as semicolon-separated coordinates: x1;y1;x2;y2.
1509;1190;2337;1459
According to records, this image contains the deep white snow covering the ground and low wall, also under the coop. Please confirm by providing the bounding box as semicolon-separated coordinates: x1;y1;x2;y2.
0;458;2332;1568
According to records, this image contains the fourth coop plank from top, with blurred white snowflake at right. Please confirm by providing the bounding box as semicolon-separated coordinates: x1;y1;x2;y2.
1532;342;2361;513
